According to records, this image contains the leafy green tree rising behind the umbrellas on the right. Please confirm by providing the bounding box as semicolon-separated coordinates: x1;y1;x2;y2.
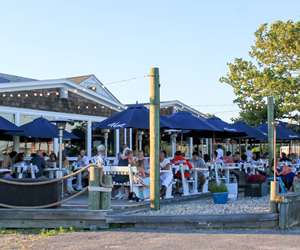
220;21;300;125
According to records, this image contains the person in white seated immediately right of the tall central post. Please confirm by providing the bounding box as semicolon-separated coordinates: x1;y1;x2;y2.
159;151;173;198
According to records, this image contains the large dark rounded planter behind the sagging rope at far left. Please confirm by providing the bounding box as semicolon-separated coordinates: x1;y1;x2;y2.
0;179;62;206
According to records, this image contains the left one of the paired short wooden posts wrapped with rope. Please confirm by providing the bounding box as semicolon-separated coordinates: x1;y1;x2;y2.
88;166;100;210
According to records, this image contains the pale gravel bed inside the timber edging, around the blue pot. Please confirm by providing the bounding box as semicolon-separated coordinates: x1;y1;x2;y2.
138;196;269;215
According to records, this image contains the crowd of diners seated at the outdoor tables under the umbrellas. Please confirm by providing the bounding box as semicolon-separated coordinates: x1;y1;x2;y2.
1;145;300;201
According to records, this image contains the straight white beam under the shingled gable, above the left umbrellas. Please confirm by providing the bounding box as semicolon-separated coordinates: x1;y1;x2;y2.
0;106;107;122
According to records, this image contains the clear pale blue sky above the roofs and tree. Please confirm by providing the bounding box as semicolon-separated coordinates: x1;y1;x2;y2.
0;0;300;120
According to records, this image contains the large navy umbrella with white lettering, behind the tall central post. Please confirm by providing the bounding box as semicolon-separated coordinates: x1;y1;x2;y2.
93;105;171;129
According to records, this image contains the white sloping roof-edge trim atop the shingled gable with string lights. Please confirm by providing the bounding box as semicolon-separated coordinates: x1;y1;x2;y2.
0;79;125;111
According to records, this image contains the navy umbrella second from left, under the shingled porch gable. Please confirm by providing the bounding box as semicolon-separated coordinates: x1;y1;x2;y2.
20;117;78;140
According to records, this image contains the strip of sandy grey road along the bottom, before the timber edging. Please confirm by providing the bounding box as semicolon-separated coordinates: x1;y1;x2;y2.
0;229;299;250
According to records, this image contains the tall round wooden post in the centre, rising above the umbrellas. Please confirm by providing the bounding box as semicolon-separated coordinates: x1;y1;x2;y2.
149;68;160;210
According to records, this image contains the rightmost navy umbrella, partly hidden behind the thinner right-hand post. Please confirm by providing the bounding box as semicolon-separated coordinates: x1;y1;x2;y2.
257;122;300;141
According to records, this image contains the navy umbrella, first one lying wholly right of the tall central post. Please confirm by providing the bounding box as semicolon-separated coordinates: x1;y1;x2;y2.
167;111;220;132
